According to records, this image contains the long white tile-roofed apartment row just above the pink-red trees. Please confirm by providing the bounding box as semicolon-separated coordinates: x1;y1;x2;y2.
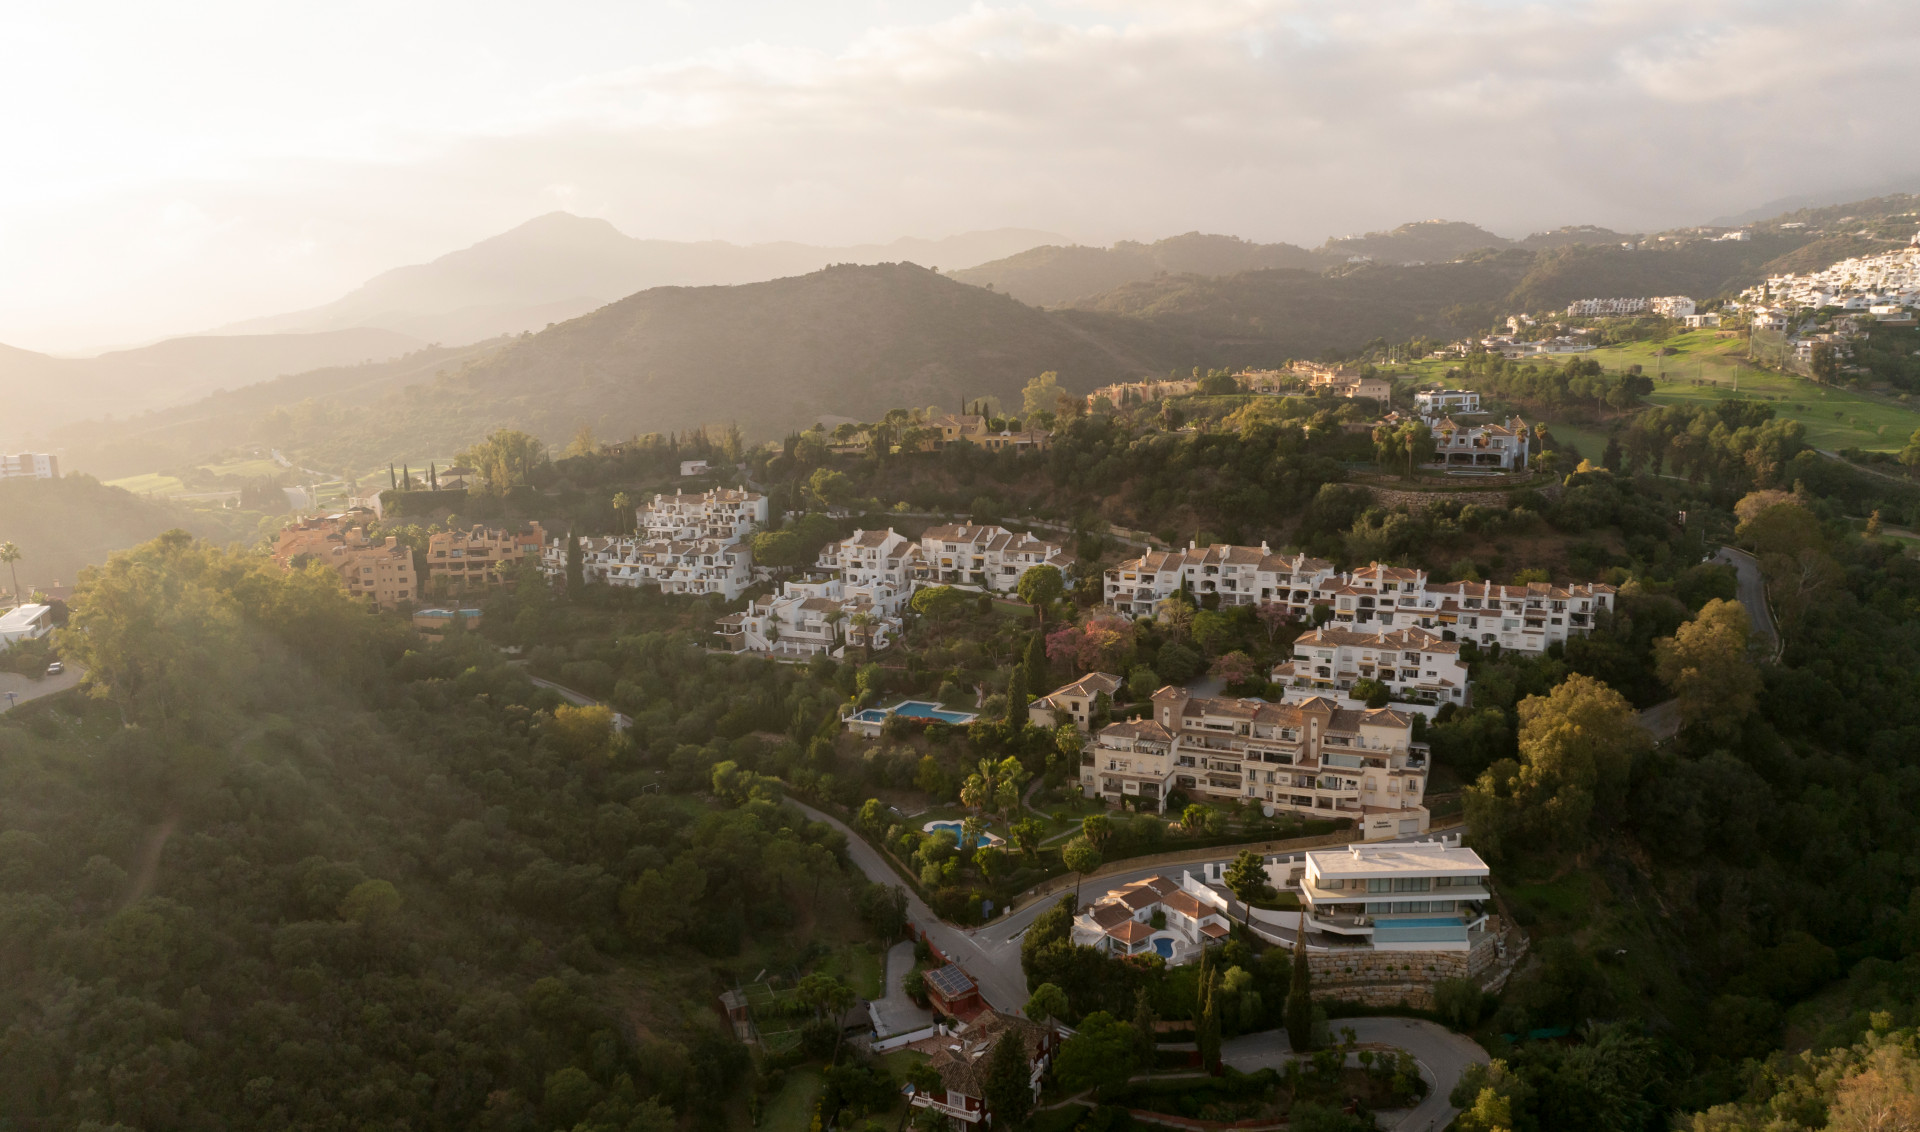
1106;543;1334;618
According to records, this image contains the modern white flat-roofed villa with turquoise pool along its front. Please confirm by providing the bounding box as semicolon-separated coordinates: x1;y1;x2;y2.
1297;840;1494;952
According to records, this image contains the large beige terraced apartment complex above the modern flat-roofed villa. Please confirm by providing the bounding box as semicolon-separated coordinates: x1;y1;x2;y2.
1081;687;1428;840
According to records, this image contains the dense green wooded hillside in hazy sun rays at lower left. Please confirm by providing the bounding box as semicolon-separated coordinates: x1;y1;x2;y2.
0;533;900;1132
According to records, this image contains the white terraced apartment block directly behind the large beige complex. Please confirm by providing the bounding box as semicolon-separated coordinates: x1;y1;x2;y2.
1273;625;1471;714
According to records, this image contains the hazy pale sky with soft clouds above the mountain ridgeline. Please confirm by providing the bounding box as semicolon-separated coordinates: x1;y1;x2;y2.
0;0;1920;349
